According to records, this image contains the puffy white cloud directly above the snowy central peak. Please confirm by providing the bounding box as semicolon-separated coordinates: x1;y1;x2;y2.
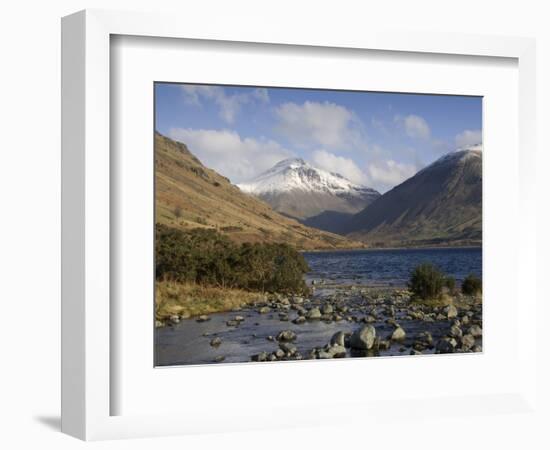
275;101;361;149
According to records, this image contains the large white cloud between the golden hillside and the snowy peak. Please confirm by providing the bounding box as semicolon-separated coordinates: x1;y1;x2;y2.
169;128;292;183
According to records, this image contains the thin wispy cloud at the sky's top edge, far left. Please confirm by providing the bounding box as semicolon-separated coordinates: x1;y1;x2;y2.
181;84;269;123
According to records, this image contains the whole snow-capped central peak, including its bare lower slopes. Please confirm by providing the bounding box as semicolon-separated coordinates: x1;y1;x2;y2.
238;158;380;220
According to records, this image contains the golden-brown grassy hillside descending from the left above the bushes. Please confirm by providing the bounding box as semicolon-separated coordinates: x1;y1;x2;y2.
155;133;363;249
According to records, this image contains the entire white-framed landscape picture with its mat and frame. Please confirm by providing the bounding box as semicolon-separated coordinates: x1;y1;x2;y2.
62;11;536;440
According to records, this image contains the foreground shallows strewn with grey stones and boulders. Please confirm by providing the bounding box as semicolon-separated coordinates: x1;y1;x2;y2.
157;286;482;365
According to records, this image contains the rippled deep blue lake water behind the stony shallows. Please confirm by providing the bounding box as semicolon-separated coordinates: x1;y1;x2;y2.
304;247;482;286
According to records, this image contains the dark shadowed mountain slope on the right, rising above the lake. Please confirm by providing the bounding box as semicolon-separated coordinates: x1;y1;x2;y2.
344;146;482;246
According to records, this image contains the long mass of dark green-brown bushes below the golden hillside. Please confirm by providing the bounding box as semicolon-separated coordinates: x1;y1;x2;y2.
155;224;309;294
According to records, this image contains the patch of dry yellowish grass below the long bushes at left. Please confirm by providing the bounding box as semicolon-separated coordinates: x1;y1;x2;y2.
155;281;262;321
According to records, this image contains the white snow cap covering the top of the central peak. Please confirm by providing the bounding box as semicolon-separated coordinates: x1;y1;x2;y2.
237;158;376;196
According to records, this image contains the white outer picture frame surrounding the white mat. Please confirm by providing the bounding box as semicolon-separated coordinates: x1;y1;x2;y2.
62;10;537;440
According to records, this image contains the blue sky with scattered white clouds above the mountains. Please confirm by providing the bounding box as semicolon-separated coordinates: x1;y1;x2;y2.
155;83;482;193
